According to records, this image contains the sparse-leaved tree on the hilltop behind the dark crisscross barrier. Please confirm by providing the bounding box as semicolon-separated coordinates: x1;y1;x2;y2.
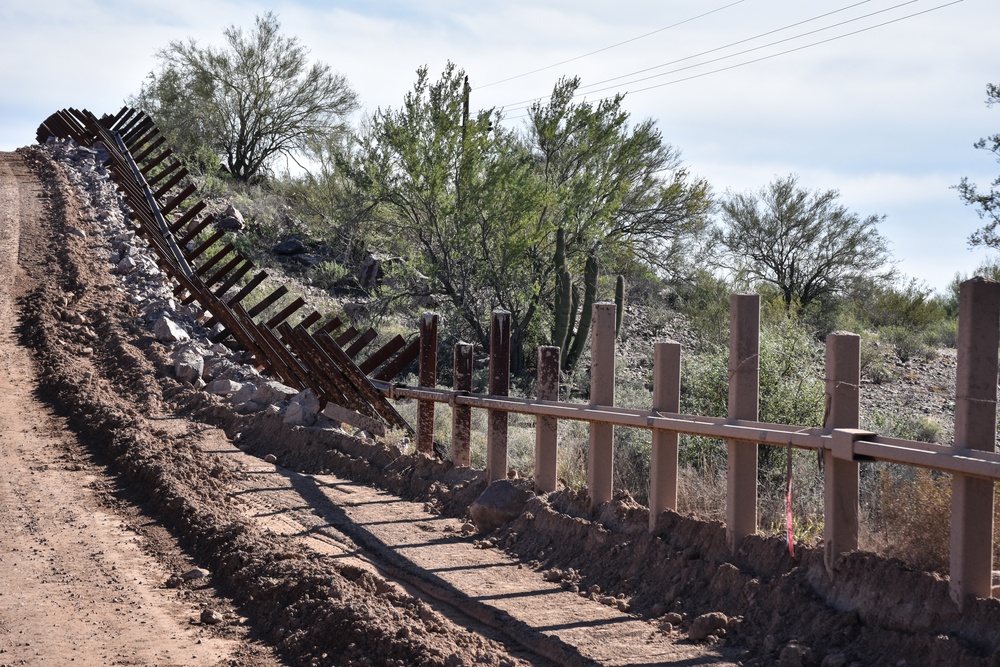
130;12;357;181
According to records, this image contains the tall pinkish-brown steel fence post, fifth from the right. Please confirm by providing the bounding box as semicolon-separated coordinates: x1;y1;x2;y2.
587;303;616;509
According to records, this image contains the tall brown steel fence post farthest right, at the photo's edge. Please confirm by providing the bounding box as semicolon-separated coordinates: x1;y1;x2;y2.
949;277;1000;606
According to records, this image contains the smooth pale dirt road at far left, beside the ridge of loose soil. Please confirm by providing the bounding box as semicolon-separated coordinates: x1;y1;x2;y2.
0;153;275;667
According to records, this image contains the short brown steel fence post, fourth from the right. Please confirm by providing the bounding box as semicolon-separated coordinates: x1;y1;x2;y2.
649;341;681;531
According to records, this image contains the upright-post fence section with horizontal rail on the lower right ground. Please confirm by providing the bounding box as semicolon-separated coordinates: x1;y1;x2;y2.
376;278;1000;603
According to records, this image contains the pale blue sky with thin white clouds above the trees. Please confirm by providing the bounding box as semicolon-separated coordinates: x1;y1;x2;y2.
0;0;1000;291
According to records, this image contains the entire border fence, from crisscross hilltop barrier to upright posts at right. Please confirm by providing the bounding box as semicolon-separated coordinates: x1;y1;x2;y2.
37;107;1000;604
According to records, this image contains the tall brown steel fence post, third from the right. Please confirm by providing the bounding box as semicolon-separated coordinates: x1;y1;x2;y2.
726;294;760;552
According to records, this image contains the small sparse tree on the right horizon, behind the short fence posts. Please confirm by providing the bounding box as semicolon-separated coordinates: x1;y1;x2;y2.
713;175;891;308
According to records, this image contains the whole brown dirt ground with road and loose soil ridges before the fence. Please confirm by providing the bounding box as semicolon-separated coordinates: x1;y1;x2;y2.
0;140;1000;667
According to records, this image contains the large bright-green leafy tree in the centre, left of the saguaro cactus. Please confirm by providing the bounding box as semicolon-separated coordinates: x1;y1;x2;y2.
355;63;710;367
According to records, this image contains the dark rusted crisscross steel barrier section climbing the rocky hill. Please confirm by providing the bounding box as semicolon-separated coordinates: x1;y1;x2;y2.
36;107;420;434
